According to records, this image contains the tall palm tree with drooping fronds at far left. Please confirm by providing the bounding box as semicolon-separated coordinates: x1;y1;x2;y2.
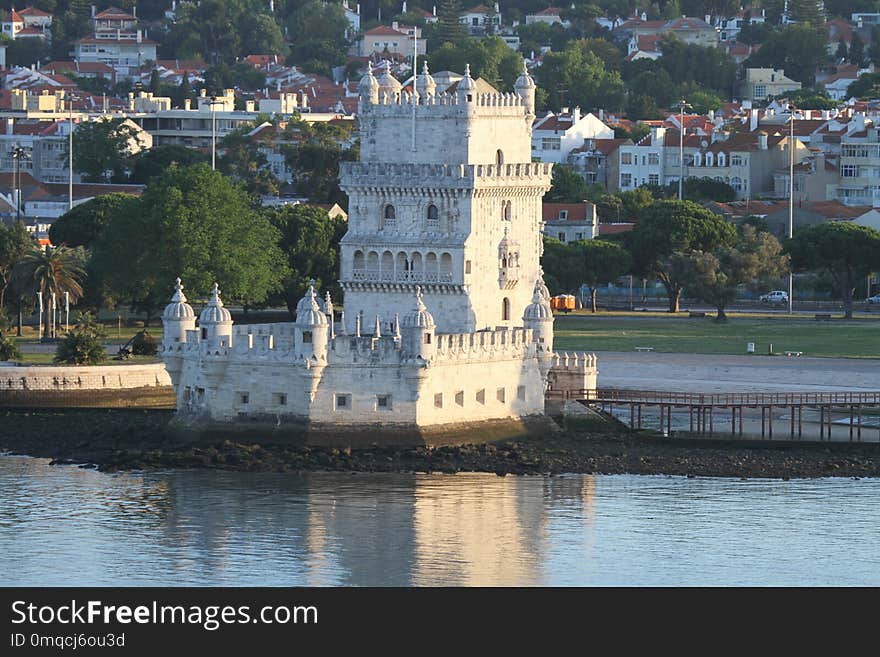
15;246;85;337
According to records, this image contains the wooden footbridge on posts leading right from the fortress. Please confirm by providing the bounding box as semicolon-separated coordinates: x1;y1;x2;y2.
547;388;880;442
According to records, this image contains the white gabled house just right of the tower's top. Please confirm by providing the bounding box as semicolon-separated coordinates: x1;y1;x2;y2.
532;107;614;164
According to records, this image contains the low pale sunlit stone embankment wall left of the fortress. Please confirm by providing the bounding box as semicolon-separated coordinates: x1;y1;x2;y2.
0;363;175;408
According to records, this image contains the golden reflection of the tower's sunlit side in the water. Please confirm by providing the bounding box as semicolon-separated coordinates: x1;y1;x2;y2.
413;474;546;586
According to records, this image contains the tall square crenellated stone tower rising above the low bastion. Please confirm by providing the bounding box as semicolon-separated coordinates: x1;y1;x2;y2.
340;62;551;333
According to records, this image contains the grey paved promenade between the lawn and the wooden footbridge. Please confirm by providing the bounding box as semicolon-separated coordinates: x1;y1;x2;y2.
596;351;880;392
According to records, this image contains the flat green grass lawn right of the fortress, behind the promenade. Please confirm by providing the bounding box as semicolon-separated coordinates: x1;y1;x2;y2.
553;313;880;358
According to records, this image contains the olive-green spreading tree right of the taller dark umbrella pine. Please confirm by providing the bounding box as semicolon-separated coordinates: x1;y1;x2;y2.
671;224;789;321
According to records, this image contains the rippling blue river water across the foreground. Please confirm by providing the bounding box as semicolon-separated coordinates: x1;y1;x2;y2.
0;456;880;586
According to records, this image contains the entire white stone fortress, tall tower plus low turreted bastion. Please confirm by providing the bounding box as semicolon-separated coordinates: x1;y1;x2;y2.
163;62;596;445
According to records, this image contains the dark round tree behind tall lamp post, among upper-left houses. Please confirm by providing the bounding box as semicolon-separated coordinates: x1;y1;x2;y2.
65;119;148;183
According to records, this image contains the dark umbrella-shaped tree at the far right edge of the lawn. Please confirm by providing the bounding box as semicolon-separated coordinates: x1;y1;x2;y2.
786;221;880;319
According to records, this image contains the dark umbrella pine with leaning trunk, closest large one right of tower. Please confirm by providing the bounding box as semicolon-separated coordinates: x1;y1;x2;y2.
631;201;736;313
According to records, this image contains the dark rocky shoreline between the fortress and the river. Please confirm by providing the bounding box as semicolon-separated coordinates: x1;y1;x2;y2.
0;409;880;479
